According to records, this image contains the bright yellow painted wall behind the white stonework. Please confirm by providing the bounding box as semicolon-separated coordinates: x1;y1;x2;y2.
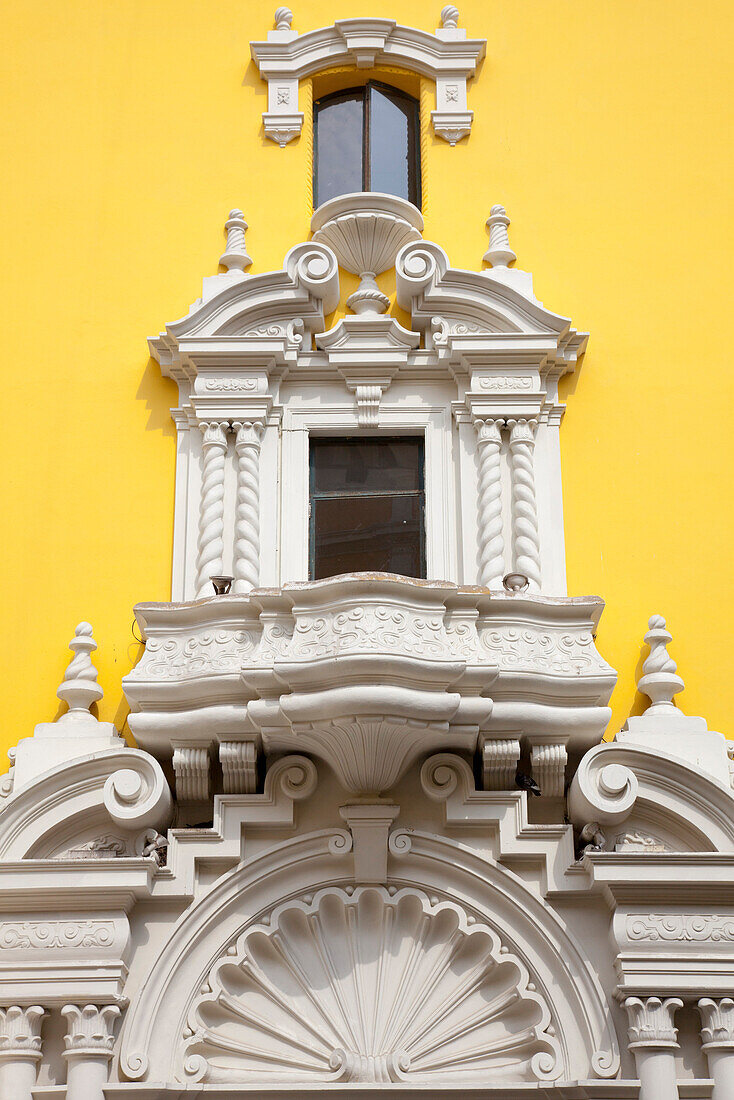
0;0;734;761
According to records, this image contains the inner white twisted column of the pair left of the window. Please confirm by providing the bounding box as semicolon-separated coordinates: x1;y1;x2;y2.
232;420;263;592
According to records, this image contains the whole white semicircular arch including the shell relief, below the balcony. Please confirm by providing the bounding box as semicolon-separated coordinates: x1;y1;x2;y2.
121;829;618;1086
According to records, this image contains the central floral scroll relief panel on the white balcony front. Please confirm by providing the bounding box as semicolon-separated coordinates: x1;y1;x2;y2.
288;604;451;658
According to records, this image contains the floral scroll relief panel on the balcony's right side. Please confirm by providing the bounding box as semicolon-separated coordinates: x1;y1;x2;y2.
480;627;609;675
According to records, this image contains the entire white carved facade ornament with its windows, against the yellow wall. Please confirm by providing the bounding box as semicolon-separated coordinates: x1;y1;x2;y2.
0;6;734;1100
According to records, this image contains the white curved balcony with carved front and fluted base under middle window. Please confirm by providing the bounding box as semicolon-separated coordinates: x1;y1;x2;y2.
124;573;614;794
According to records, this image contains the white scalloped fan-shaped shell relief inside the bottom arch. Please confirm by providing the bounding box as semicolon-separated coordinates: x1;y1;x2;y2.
183;887;565;1084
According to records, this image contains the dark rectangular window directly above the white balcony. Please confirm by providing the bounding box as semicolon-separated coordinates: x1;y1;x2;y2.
310;438;426;581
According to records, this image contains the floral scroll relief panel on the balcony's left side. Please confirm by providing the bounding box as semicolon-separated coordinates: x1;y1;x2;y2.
129;630;255;680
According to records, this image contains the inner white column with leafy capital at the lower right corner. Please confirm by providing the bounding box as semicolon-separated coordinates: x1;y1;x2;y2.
624;997;683;1100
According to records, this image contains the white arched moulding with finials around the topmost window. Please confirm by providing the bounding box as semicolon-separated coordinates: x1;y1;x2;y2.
250;7;486;147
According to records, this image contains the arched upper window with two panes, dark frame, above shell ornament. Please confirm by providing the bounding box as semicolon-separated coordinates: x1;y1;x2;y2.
314;84;420;207
